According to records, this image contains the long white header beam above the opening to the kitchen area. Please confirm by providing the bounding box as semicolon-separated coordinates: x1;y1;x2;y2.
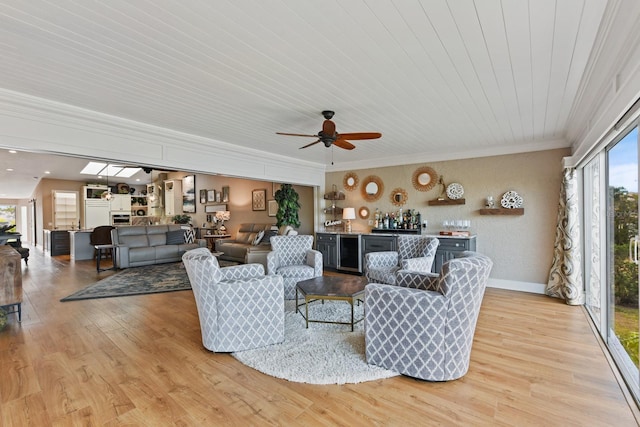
0;89;325;186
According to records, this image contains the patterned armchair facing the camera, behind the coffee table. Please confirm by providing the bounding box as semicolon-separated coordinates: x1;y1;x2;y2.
267;235;322;299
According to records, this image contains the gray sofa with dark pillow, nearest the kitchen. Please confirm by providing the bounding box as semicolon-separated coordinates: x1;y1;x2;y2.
111;224;207;268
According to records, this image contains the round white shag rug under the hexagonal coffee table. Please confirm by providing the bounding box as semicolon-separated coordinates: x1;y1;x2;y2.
232;301;399;384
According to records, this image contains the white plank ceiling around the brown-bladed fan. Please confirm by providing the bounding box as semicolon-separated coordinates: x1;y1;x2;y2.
0;0;606;171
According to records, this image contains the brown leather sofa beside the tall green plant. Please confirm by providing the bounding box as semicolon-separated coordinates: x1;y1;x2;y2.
216;223;277;268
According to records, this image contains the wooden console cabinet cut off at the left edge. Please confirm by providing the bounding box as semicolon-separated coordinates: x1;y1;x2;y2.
0;245;22;322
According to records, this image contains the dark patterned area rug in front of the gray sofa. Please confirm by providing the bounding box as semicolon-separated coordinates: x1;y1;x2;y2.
60;261;237;302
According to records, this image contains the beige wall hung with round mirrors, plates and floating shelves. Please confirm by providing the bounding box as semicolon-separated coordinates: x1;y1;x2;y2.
325;149;570;283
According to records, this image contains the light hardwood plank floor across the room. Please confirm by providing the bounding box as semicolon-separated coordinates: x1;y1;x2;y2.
0;248;637;426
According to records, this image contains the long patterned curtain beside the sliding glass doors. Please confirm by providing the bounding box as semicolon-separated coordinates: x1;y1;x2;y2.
545;168;585;305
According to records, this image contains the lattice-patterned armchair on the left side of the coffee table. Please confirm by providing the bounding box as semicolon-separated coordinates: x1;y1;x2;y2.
182;248;284;352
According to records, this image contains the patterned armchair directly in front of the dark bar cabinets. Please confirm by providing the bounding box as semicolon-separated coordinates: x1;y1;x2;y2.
364;235;440;285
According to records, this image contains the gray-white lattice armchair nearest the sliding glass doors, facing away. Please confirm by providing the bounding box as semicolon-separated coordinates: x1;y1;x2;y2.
364;252;493;381
